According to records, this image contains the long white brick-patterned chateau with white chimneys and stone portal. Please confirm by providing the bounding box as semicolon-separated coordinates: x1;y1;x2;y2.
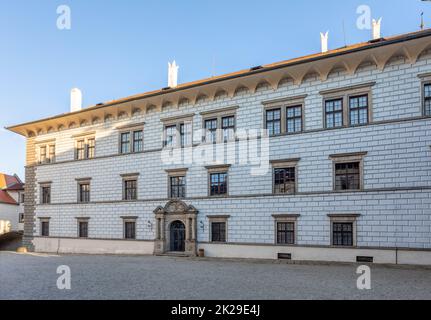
8;30;431;265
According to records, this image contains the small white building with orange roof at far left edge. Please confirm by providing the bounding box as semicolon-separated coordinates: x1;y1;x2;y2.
0;173;24;235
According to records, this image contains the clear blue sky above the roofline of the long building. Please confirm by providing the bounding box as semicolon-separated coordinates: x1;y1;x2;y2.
0;0;431;177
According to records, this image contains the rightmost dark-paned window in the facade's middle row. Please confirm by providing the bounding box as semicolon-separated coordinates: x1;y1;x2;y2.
335;162;361;191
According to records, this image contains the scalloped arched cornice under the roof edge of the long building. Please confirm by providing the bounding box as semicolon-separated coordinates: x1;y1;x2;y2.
7;29;431;137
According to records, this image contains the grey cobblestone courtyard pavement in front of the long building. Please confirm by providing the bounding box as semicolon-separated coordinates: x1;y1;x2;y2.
0;252;431;300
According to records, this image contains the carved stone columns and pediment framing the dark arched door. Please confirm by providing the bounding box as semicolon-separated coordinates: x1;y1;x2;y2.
154;200;198;256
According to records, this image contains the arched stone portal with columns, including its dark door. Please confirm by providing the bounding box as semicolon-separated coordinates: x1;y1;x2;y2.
154;200;198;256
